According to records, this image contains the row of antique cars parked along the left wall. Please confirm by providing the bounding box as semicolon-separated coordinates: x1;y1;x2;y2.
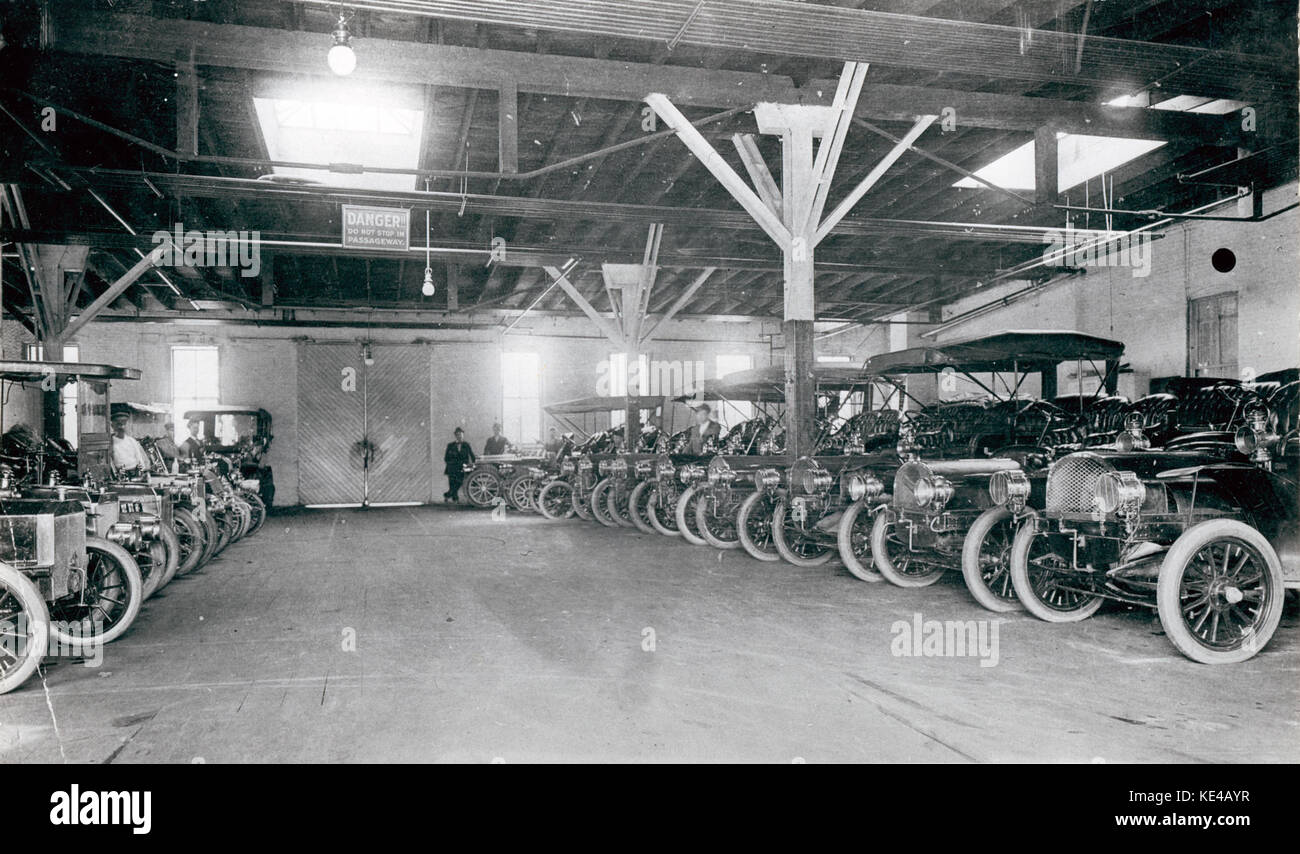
0;361;270;694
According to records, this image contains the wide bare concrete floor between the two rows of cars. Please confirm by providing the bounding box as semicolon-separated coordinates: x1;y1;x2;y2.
0;507;1300;763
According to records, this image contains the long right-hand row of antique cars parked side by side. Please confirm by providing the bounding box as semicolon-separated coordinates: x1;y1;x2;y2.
486;331;1300;663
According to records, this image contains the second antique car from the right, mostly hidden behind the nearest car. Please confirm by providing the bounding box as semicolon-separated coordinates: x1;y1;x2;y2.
962;377;1281;611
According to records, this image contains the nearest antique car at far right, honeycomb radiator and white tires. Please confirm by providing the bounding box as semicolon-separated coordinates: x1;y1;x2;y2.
1010;382;1300;664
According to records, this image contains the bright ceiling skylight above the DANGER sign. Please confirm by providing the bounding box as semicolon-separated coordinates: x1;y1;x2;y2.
254;97;424;190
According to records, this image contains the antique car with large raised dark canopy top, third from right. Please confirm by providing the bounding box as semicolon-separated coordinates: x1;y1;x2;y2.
840;331;1123;610
